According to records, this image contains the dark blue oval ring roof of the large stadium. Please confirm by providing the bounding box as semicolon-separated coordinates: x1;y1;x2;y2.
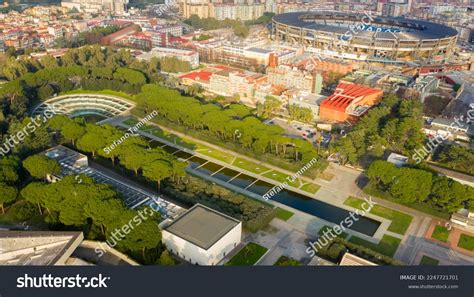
273;12;458;40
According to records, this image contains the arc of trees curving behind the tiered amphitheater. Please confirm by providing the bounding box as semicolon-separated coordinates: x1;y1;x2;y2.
0;47;148;118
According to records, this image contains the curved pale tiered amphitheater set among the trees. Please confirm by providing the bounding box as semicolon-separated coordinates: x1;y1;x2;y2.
32;93;135;118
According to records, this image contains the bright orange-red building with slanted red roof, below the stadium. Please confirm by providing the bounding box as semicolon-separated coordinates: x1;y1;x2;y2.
319;82;383;122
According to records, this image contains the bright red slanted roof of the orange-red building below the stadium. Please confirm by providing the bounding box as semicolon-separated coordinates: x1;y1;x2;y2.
320;82;383;112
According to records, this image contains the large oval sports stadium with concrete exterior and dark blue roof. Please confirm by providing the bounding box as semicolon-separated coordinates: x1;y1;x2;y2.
272;12;458;63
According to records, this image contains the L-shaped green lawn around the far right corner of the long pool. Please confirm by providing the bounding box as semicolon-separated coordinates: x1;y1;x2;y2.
344;197;413;235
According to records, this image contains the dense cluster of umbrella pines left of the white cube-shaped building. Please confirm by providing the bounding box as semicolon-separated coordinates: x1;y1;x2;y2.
20;168;161;258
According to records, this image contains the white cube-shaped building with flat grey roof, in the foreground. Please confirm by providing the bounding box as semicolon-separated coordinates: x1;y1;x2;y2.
162;204;242;265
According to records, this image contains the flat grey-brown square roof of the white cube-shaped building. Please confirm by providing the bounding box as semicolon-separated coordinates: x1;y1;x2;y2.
165;204;240;250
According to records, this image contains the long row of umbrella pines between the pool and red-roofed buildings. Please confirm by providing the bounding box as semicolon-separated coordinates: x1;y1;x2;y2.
135;85;321;165
